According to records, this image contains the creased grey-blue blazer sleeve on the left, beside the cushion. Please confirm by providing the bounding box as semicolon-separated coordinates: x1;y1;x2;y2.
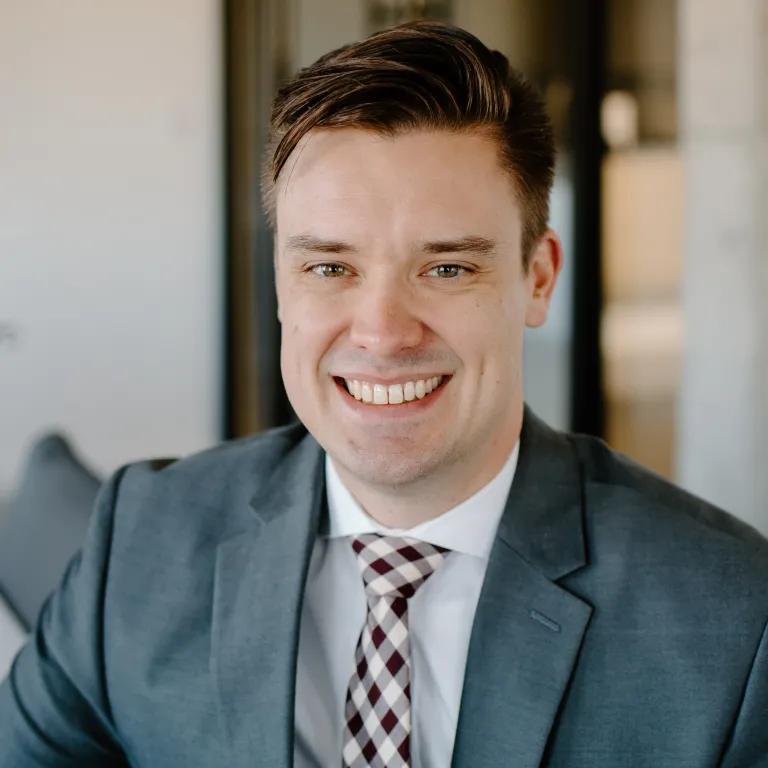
0;470;128;768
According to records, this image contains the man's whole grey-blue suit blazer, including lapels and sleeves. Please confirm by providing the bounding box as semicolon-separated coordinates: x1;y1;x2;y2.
0;411;768;768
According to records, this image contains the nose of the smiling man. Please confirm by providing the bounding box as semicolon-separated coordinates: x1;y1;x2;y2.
350;275;424;357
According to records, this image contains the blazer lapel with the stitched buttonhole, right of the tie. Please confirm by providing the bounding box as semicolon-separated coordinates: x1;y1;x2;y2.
453;410;592;768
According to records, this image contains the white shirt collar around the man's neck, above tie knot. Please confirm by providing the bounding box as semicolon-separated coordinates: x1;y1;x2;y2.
325;441;520;559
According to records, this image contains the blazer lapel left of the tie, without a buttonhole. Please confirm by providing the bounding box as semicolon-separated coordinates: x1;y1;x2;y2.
211;437;325;768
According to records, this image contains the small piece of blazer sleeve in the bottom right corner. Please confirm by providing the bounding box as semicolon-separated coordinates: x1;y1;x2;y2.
720;624;768;768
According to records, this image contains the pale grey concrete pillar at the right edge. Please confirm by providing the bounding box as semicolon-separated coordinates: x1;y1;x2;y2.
678;0;768;533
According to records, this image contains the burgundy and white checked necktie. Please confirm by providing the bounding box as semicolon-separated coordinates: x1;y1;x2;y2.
342;534;448;768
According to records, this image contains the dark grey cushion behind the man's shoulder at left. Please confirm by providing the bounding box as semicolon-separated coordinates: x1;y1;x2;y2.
0;434;100;628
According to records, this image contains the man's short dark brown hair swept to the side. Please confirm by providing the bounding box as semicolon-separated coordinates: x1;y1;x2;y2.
262;21;555;268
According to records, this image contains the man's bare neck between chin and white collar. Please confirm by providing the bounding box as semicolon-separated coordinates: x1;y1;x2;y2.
334;430;520;530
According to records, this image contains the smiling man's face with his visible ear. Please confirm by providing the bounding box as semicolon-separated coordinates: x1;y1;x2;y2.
275;129;559;488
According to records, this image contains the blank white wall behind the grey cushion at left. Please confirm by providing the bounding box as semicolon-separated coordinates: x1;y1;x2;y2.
0;0;223;495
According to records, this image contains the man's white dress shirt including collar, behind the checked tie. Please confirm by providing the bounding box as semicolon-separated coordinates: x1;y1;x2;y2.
294;444;519;768
